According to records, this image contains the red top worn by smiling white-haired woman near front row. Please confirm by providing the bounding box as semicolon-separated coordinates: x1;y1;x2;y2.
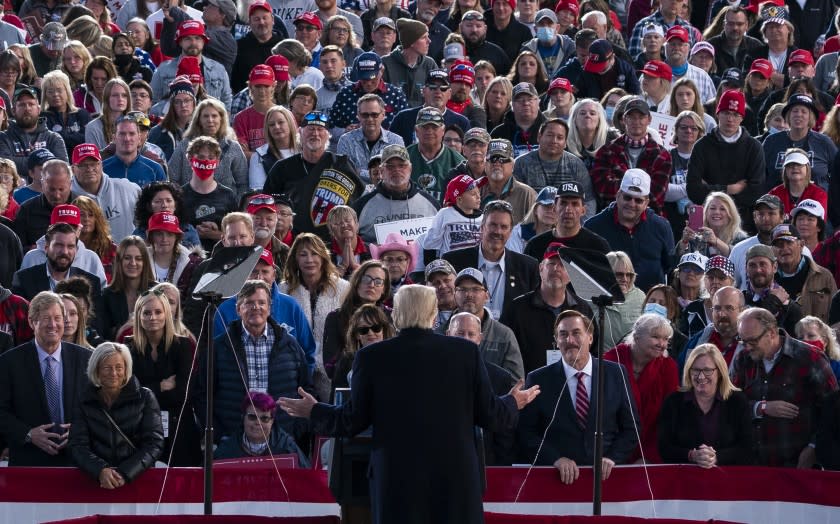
604;344;679;464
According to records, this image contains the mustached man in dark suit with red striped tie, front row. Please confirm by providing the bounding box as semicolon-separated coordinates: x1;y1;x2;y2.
517;310;639;484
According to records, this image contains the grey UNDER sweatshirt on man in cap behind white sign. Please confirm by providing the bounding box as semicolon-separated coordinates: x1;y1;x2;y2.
353;182;440;243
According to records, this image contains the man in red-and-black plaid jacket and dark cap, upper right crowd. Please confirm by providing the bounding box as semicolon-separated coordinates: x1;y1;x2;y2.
591;99;671;214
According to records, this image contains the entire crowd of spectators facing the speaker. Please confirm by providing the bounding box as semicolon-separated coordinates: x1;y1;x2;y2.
0;0;840;500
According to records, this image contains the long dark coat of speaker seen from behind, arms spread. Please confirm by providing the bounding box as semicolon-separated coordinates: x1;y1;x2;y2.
311;328;519;524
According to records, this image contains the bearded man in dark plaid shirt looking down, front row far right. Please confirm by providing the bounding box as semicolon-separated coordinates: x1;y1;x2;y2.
731;308;837;468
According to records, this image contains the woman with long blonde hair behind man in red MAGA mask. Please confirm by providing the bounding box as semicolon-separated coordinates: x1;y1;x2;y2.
169;98;248;196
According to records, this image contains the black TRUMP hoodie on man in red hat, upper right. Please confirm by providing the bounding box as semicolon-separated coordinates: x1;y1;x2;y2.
686;127;765;217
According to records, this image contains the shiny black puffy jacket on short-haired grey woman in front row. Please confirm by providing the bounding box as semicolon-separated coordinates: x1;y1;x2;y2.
68;377;163;482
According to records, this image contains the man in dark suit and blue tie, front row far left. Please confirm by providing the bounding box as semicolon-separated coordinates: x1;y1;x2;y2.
0;291;90;467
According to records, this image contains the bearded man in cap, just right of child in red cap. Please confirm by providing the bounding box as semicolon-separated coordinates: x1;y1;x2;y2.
481;138;537;224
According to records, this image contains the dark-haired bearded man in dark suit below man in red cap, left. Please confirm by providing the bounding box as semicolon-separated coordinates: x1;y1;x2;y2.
12;222;102;305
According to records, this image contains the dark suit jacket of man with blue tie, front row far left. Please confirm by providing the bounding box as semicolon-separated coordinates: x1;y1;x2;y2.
0;340;90;467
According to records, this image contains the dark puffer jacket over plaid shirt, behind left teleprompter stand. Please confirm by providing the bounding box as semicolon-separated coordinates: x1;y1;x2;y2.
193;317;312;442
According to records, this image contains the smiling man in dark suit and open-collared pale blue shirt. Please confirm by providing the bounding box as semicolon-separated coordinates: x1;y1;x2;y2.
443;200;539;320
